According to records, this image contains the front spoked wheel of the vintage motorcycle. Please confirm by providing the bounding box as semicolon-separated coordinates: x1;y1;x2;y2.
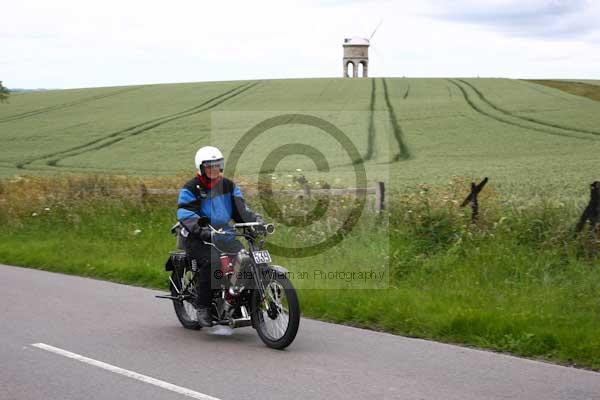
252;274;300;349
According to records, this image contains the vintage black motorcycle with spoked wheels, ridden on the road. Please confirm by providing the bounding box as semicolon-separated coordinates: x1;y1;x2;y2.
156;222;300;349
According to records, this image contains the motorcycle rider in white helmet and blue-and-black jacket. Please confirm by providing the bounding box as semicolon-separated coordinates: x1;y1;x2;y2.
177;146;262;327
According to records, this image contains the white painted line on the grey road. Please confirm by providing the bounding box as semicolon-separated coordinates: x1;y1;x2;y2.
32;343;219;400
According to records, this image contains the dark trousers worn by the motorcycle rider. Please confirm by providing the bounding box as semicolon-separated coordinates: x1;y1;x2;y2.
185;238;243;307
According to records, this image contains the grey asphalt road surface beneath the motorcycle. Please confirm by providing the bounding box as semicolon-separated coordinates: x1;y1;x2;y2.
0;265;600;400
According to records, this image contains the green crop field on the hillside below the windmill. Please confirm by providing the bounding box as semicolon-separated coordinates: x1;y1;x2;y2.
0;78;600;198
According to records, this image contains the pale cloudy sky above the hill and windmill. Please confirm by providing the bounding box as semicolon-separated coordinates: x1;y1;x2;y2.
0;0;600;89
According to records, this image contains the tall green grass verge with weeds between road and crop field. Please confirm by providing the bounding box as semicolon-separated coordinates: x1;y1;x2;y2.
0;177;600;369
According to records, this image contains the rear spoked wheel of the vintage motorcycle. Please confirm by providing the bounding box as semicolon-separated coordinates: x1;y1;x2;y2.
171;260;202;330
